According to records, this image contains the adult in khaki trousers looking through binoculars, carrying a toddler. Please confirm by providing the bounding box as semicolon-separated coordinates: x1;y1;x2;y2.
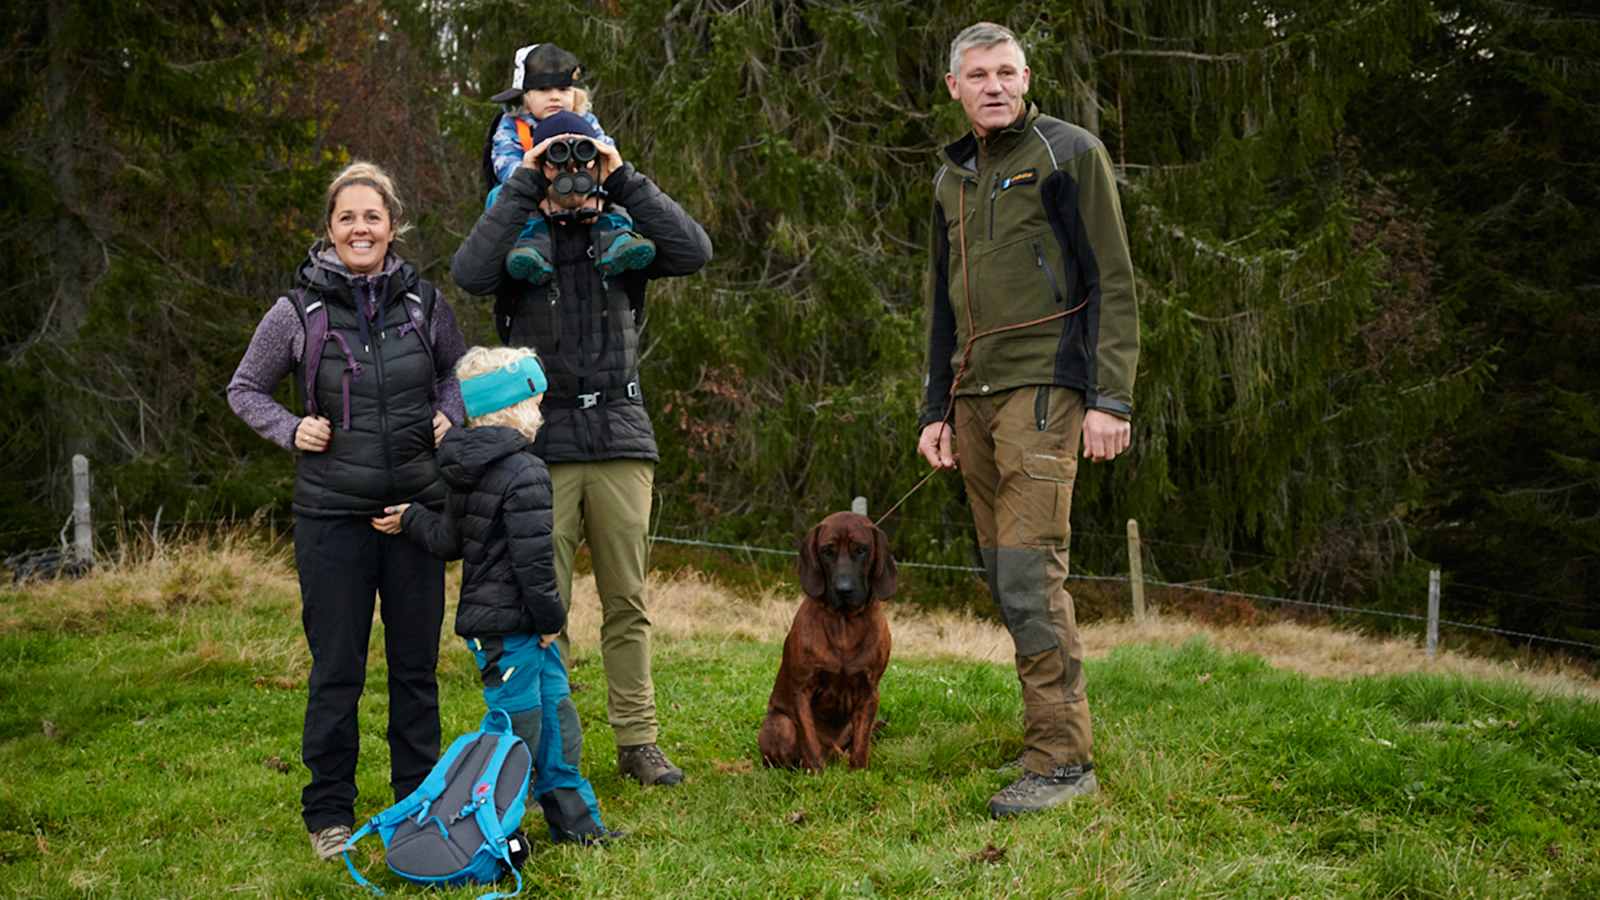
451;112;712;785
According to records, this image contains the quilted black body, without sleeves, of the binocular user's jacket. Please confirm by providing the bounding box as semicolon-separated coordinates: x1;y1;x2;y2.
504;217;658;463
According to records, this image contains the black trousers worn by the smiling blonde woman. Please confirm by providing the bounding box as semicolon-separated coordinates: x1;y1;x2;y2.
294;516;445;831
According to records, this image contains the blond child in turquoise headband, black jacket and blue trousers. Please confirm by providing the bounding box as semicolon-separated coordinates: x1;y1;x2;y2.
373;348;613;842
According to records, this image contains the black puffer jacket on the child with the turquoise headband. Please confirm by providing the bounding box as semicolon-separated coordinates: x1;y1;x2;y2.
400;426;566;637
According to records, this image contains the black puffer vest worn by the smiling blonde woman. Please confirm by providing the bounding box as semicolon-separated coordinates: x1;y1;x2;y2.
291;245;446;516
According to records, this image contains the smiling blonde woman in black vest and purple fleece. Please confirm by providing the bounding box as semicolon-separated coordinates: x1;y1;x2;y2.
227;162;466;860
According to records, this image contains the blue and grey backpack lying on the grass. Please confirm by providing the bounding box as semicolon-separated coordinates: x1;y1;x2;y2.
344;709;533;900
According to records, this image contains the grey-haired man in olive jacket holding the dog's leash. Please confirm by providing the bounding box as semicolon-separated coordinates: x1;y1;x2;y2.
917;22;1139;817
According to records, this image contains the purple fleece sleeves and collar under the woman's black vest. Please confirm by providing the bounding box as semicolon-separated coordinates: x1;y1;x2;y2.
227;248;467;450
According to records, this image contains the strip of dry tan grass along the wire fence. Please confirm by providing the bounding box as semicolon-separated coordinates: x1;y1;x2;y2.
9;535;1600;697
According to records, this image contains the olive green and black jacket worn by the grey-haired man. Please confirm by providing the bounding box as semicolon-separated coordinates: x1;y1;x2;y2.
922;104;1139;424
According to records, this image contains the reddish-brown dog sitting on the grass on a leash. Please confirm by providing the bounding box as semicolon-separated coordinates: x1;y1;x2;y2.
757;512;896;772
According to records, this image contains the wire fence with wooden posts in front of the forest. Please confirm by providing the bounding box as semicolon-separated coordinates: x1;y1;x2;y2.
12;456;1600;657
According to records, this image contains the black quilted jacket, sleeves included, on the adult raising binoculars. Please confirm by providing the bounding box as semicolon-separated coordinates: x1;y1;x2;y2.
451;163;712;466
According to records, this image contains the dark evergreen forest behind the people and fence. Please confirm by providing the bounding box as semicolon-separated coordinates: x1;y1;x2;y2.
0;0;1600;641
